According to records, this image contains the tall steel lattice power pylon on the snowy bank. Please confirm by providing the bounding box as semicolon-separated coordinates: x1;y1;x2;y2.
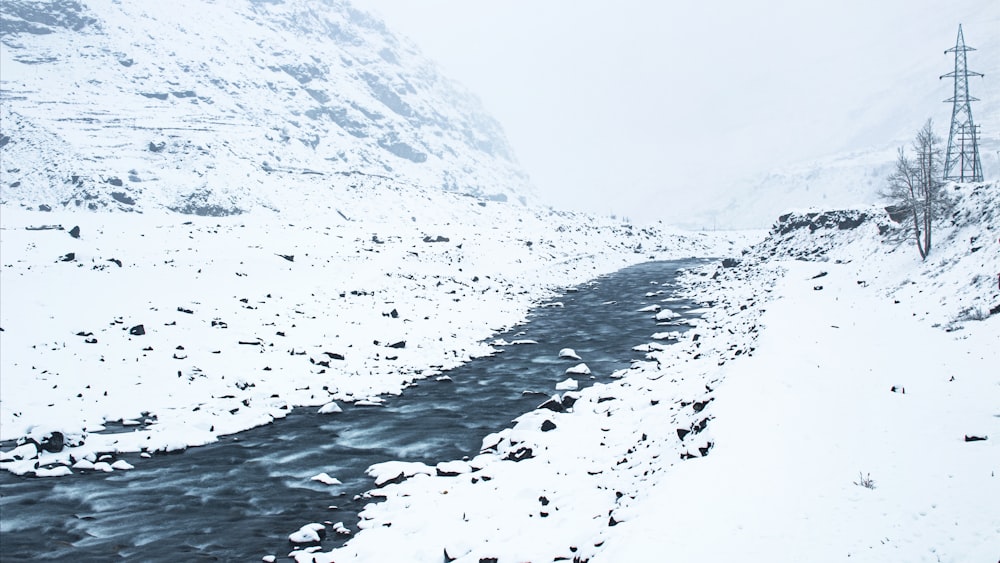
941;24;983;182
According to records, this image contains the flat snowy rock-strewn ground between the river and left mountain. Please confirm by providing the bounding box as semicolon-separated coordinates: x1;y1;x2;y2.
0;177;733;475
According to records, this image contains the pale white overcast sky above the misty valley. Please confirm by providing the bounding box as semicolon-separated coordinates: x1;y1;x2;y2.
353;0;1000;225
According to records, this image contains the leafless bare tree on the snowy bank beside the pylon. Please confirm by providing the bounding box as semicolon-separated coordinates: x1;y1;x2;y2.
883;119;947;260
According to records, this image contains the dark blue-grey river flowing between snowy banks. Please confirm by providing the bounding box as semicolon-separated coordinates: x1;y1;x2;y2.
0;260;698;562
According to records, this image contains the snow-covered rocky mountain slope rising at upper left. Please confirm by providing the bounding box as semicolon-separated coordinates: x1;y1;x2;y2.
0;0;532;215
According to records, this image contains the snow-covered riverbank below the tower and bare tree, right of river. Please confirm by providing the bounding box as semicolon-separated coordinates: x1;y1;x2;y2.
295;183;1000;562
